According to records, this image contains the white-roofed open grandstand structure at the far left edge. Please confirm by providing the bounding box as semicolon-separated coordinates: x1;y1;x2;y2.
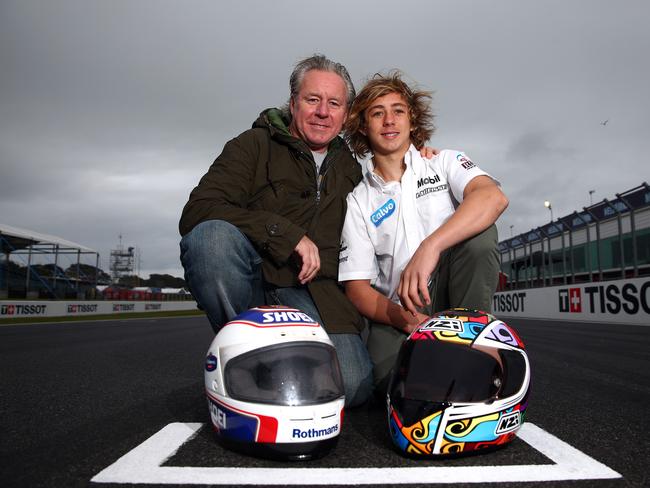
0;224;99;299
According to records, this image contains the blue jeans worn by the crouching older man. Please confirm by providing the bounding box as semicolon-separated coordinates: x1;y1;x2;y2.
180;220;373;407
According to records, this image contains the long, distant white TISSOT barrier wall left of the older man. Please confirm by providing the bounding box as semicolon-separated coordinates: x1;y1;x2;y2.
0;300;197;319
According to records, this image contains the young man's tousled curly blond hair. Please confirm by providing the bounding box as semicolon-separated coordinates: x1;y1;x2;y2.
343;70;435;158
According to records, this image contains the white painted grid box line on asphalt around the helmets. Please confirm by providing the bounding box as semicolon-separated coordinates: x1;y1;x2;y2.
91;423;622;485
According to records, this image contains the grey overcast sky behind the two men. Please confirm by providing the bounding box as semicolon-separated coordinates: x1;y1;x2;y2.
0;0;650;277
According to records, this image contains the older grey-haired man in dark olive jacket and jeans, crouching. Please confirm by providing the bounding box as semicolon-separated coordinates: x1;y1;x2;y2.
179;55;372;406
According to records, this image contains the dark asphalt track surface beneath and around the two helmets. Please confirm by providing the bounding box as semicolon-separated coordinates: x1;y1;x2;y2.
0;316;650;487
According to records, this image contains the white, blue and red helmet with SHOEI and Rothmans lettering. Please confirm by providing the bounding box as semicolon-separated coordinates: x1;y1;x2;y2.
205;307;345;460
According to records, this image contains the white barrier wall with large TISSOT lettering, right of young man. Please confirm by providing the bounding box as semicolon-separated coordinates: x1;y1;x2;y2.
492;278;650;325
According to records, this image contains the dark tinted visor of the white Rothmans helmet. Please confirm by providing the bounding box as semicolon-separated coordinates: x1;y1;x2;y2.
224;342;344;405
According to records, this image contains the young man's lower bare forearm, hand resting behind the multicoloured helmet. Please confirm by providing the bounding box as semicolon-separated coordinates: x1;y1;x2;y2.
344;280;428;334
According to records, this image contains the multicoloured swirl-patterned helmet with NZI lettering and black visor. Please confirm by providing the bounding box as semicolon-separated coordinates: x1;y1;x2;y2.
387;309;530;456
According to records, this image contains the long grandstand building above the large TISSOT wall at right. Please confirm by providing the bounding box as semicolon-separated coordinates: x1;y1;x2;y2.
499;182;650;290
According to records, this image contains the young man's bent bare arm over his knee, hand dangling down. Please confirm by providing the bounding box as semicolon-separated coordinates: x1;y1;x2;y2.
397;175;508;314
